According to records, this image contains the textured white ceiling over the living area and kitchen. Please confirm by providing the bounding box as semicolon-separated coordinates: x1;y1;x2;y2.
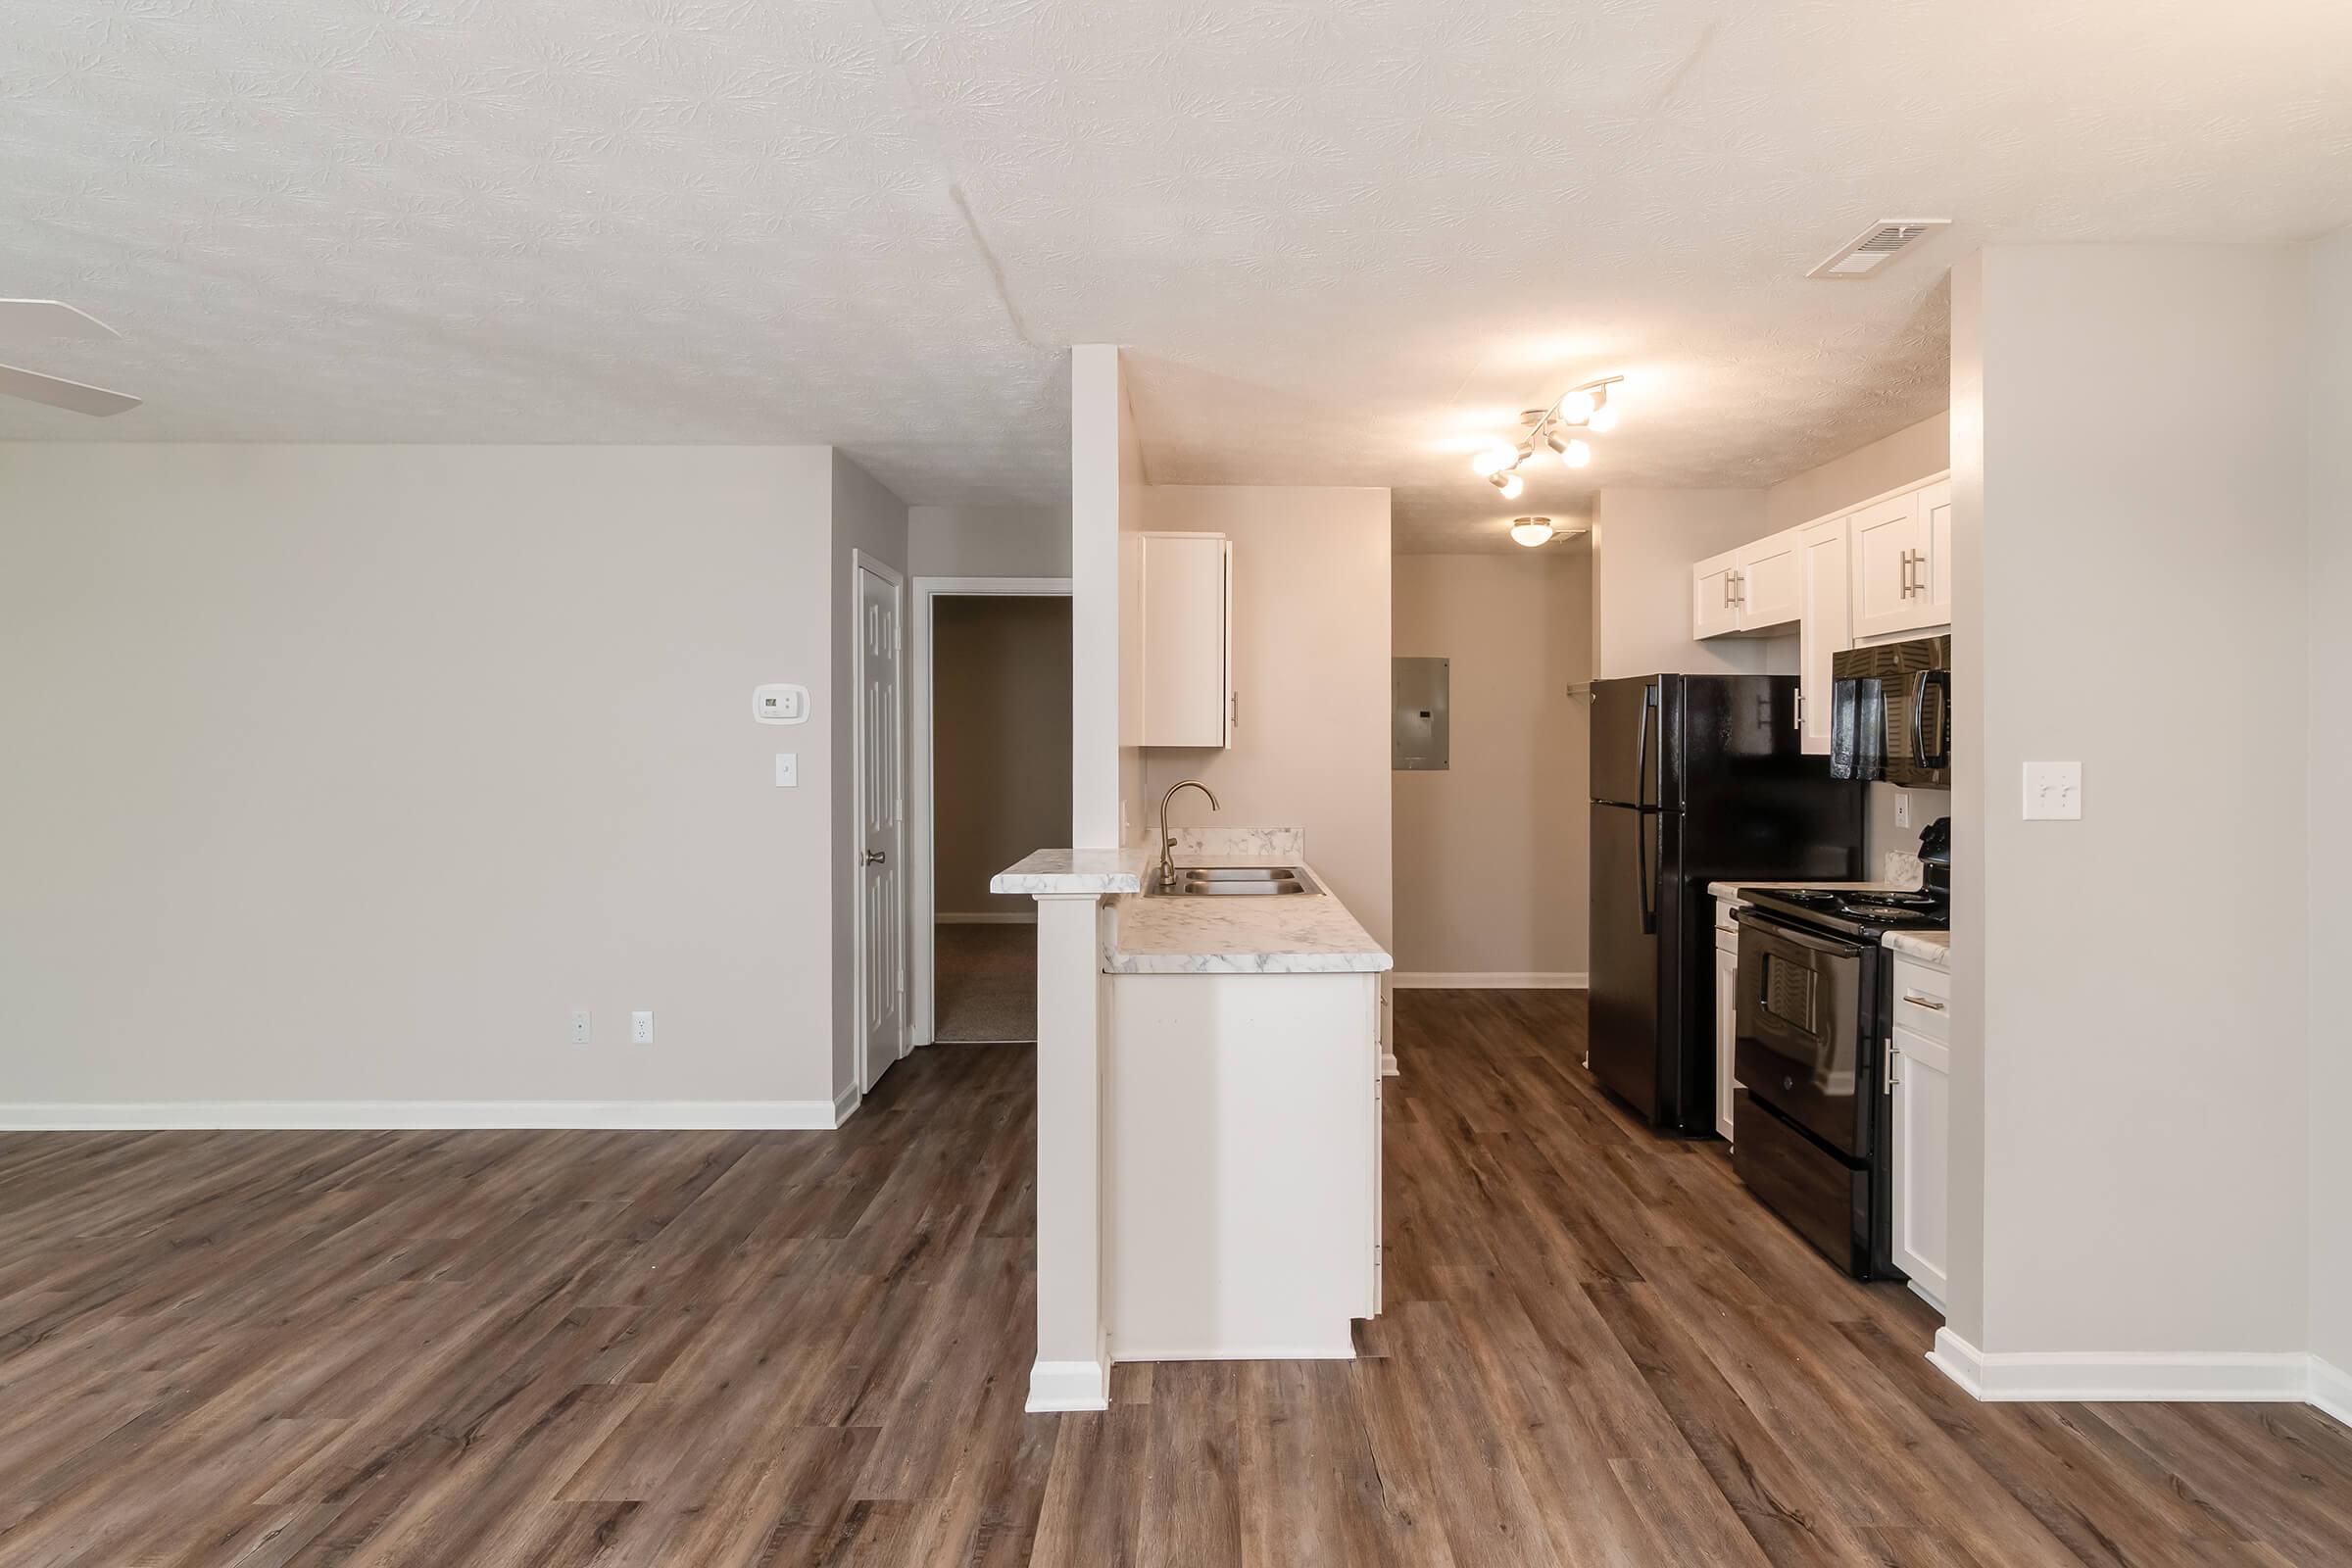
0;0;2352;550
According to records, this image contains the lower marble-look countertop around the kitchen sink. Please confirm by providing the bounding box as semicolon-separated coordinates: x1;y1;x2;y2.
1103;854;1395;976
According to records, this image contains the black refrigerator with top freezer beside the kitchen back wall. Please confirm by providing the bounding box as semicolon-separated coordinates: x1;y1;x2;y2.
1590;674;1863;1138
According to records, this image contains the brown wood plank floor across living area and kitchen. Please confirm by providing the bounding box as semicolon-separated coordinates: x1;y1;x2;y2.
0;992;2352;1568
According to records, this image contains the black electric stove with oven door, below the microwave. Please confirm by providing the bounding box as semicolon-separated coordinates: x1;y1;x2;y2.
1731;820;1952;1279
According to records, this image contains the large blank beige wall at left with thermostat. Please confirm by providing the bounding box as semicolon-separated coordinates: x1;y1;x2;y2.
0;444;865;1104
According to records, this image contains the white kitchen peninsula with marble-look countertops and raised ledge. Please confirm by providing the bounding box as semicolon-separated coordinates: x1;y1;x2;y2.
990;830;1390;1410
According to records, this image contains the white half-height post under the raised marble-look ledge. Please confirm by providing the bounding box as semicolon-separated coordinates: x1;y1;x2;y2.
1028;894;1110;1410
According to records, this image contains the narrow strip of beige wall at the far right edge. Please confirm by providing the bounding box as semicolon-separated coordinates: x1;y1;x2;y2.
2305;228;2352;1375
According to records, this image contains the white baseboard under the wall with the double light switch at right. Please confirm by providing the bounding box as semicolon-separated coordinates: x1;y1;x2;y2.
1927;1328;2333;1408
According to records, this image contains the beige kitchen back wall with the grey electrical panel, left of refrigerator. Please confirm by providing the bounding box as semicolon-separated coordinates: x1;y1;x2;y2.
1390;555;1592;976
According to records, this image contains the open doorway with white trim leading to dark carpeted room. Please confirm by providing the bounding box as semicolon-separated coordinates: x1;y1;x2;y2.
910;578;1070;1046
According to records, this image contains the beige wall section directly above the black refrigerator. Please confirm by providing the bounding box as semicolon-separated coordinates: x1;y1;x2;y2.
1590;489;1797;679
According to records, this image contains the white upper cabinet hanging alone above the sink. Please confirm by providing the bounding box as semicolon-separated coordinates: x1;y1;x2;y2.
1139;534;1233;745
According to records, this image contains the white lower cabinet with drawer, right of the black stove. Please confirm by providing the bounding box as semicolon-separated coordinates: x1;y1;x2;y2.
1888;959;1952;1312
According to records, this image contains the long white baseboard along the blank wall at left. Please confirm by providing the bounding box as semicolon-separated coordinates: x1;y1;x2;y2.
0;1089;858;1133
